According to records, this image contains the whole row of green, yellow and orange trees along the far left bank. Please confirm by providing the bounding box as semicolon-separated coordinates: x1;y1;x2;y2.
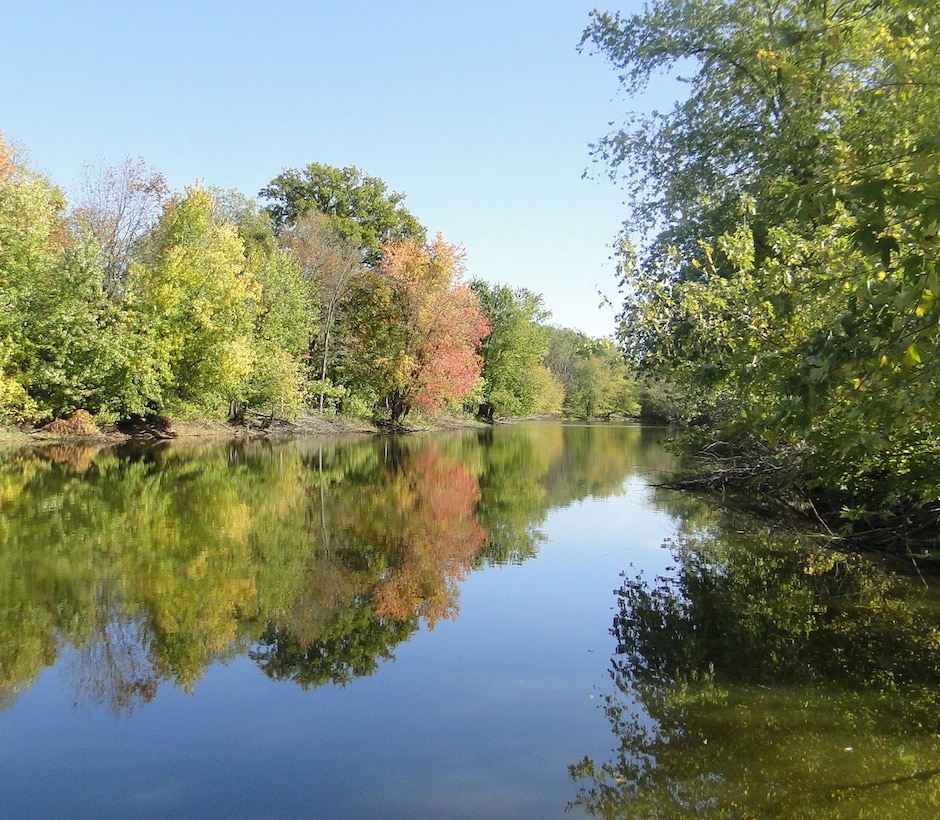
0;137;638;424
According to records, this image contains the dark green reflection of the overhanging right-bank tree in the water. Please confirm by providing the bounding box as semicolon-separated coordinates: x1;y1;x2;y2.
571;515;940;817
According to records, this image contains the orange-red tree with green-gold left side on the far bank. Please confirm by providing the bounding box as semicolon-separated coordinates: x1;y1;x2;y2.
349;234;489;423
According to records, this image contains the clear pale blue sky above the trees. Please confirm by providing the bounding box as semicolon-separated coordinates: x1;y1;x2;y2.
0;0;660;336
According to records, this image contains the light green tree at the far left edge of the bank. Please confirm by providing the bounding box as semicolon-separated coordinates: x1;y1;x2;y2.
0;133;120;422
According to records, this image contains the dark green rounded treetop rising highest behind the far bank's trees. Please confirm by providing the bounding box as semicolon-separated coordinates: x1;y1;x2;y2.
259;162;426;266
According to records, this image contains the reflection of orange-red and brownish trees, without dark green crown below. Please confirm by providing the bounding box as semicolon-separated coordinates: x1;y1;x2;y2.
286;439;486;639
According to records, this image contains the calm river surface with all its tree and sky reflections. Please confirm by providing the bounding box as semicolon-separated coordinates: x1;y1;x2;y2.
0;424;940;818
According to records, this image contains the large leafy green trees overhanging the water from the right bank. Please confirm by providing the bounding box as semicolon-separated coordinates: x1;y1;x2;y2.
582;0;940;548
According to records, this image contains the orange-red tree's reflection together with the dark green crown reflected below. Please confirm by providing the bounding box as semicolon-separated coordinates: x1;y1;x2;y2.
250;439;486;688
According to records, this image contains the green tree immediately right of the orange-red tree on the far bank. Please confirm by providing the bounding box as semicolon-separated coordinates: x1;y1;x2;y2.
471;280;561;420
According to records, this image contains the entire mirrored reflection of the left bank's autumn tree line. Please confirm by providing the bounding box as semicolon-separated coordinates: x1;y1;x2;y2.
0;424;668;714
